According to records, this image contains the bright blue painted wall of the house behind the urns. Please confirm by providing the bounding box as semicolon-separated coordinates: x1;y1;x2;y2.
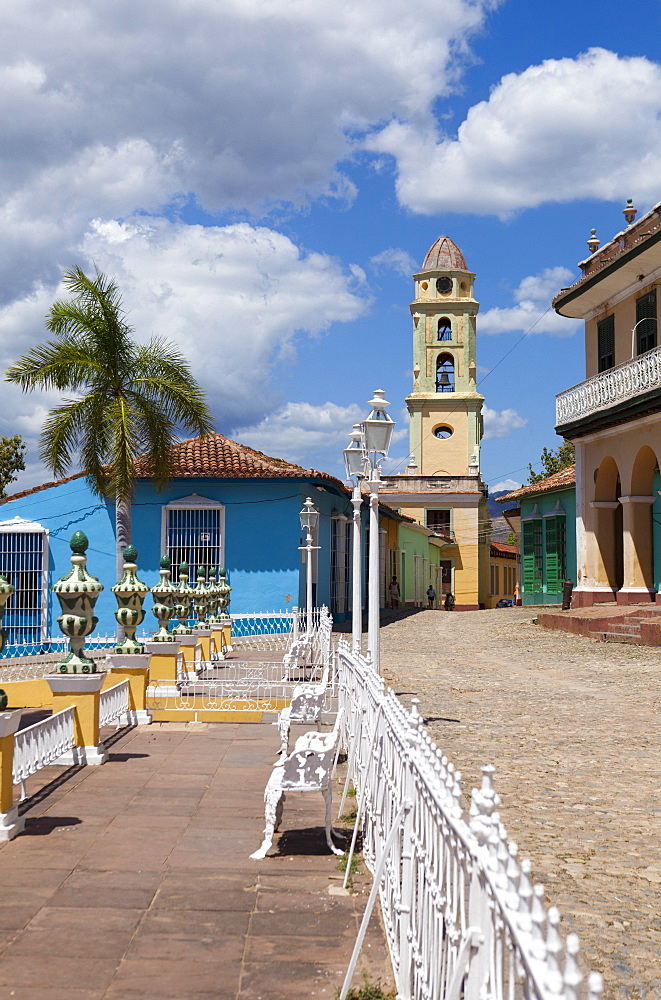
0;478;351;635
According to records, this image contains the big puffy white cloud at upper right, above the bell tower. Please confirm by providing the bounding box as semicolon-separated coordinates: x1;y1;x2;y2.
368;48;661;216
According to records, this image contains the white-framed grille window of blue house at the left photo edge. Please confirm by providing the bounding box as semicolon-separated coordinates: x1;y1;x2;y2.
0;528;47;646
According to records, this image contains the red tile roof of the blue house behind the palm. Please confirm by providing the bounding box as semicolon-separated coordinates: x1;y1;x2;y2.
0;433;345;505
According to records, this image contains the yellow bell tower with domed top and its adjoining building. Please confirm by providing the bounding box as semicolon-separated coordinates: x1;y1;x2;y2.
381;236;489;610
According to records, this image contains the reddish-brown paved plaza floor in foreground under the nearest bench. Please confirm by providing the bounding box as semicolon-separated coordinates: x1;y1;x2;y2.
0;723;391;1000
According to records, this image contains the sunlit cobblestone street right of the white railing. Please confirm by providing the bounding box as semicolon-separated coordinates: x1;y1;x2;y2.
381;608;661;1000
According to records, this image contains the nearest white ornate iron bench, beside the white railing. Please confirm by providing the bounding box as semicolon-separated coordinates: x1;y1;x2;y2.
250;713;344;861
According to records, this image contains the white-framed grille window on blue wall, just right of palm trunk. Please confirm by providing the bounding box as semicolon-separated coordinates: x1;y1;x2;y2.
165;507;223;583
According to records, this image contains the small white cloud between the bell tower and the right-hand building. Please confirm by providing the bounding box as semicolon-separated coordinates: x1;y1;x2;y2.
477;267;582;337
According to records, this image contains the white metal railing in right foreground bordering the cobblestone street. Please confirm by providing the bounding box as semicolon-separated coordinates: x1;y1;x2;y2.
337;640;602;1000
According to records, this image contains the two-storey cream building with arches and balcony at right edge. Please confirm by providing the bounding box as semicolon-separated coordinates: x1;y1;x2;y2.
553;201;661;606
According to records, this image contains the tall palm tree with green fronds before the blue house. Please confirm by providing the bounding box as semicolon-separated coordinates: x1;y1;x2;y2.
5;267;213;579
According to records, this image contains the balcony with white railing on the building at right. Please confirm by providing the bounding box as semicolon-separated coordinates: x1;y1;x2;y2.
555;347;661;438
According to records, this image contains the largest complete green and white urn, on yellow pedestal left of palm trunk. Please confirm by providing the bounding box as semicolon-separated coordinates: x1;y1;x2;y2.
53;531;103;674
